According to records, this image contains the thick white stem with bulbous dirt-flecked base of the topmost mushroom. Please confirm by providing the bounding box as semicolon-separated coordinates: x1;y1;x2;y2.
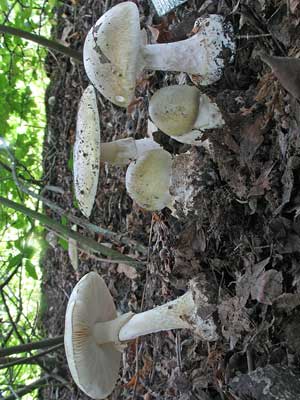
142;14;234;85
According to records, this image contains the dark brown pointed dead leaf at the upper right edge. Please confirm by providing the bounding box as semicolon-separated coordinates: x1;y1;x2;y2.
260;53;300;99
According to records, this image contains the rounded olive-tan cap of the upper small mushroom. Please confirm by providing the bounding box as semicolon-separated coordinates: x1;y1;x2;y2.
149;85;200;136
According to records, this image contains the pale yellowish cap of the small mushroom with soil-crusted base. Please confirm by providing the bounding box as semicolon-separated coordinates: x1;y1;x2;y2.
126;149;173;211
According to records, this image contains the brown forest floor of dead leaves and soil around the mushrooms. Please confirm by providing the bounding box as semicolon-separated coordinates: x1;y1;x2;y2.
42;0;300;400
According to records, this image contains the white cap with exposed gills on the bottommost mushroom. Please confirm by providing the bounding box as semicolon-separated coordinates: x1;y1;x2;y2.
64;272;121;399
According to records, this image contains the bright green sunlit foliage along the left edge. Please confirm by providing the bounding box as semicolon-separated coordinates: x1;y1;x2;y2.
0;0;56;398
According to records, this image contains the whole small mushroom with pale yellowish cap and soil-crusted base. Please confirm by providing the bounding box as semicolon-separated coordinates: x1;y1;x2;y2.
125;147;218;218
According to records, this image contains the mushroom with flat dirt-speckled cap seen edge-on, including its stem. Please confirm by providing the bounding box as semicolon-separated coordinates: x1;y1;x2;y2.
73;85;160;217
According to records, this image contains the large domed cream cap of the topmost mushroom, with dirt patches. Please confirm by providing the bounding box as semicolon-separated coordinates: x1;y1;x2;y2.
83;1;141;107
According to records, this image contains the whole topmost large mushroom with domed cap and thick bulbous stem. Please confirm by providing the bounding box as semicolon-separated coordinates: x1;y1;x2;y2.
83;1;235;107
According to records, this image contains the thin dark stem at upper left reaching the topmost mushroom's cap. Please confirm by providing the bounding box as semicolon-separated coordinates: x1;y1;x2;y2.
0;24;83;63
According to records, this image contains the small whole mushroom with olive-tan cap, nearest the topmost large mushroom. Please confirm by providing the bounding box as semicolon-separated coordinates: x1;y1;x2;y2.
149;85;225;146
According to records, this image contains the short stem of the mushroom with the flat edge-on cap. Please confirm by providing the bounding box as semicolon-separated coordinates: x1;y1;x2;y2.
100;138;160;165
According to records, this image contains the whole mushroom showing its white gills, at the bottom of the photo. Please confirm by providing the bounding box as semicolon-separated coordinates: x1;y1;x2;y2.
64;272;218;399
